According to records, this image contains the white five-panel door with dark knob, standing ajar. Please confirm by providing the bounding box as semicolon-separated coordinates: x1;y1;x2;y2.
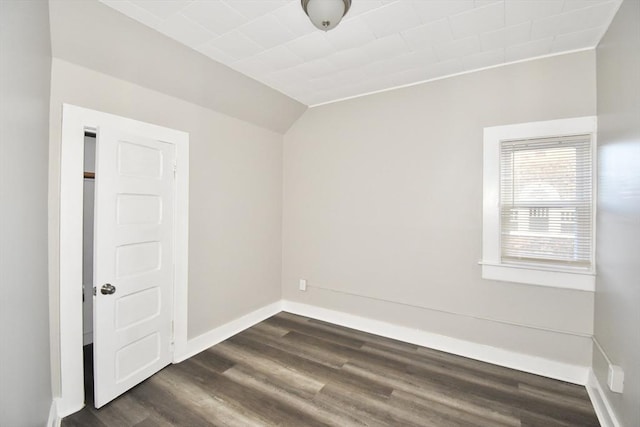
93;126;175;408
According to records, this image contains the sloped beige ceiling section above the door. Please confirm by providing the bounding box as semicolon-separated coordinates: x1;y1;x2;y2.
49;0;307;133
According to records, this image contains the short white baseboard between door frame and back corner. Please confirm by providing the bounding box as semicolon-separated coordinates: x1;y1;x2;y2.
176;301;282;362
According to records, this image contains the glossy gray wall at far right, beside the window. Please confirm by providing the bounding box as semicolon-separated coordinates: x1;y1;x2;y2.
593;0;640;427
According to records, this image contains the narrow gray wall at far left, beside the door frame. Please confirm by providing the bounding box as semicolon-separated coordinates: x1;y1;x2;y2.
0;1;51;426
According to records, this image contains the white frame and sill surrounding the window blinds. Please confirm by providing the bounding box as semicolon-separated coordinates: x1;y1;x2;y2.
480;116;598;292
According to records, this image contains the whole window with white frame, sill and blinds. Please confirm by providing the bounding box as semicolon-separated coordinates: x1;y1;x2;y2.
482;117;596;290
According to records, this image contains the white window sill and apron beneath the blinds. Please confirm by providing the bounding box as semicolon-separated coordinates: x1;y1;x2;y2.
480;261;596;292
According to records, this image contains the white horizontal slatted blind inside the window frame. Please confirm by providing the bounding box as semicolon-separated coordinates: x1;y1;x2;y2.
500;135;593;269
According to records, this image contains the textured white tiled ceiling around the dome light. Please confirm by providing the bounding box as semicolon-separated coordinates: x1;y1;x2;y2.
100;0;620;106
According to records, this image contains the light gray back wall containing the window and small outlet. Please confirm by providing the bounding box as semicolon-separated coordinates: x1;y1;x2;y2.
283;51;596;367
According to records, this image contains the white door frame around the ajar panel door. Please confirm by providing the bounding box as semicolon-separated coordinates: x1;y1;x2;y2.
57;104;189;416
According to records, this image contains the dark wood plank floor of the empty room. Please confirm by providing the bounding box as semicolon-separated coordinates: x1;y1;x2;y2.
62;313;599;427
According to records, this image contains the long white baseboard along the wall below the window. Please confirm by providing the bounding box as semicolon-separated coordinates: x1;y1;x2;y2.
282;300;589;385
